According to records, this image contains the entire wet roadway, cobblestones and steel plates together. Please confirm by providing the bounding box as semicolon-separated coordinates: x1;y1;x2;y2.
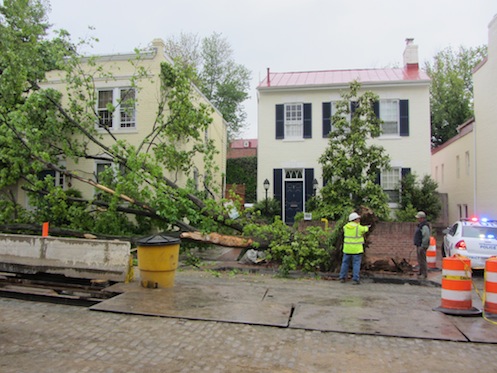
0;260;497;372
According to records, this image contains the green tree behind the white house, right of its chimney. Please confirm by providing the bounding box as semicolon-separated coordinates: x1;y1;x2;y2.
425;45;487;147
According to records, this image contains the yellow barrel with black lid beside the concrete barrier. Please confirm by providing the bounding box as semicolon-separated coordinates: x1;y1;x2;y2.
137;234;181;288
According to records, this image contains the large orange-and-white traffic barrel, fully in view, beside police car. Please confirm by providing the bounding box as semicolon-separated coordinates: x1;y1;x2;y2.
433;256;481;316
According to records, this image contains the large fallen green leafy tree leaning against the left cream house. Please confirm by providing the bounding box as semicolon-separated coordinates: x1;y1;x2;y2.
0;0;254;244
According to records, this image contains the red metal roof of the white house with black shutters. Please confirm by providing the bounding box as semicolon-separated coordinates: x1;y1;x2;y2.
258;67;430;88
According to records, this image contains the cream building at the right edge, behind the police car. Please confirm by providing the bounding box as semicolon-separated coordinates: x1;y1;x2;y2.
432;15;497;224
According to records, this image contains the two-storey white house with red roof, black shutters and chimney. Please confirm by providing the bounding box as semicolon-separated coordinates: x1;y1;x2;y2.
257;39;431;223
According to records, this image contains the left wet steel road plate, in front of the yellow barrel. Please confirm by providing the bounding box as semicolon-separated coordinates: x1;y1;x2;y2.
90;285;291;327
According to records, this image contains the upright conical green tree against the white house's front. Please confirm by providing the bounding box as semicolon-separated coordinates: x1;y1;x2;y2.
319;81;389;219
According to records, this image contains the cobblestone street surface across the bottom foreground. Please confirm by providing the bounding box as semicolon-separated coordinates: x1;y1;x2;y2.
0;268;497;372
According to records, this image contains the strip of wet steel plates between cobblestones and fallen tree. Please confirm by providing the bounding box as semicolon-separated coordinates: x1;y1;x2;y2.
90;264;497;343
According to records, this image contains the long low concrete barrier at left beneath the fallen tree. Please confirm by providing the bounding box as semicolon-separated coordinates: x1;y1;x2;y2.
0;234;131;281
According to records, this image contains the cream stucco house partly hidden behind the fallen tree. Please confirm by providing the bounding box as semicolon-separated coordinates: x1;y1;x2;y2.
18;39;227;207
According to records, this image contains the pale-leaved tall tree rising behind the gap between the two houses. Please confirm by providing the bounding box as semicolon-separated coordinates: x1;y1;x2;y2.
166;33;251;140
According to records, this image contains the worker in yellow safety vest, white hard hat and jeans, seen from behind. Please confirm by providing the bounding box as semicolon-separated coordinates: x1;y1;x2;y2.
339;212;369;285
